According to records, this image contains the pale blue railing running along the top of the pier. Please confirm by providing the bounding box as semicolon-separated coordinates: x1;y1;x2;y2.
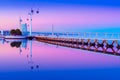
39;32;120;40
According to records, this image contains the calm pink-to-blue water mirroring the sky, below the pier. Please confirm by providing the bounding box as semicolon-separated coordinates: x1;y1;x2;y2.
0;40;120;80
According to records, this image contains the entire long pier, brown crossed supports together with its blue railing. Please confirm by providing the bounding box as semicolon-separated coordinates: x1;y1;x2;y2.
35;33;120;56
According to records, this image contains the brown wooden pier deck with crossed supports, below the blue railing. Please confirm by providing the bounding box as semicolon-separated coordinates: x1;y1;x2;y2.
35;36;120;56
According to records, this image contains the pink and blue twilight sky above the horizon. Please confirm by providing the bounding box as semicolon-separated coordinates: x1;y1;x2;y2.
0;0;120;32
